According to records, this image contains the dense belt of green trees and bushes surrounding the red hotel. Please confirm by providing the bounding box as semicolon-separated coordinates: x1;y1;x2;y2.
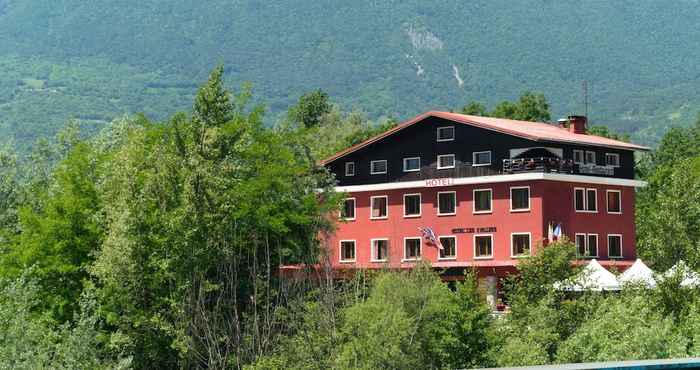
0;68;700;369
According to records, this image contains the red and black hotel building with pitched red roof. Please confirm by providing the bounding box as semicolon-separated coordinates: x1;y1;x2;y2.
323;112;647;294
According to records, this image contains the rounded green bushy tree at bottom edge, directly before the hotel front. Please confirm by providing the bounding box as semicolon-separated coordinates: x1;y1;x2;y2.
337;266;490;369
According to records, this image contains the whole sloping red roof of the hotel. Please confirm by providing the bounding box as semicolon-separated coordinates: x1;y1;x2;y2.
321;111;649;164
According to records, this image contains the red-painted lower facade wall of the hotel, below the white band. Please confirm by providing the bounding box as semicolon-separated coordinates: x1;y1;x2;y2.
326;180;636;268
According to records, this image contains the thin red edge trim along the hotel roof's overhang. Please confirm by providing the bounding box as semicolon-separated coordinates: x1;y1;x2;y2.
320;111;650;166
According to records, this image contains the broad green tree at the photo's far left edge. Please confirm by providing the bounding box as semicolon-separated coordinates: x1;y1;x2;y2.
0;143;103;320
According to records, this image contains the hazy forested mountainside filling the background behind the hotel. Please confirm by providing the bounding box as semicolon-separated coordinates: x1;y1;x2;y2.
0;0;700;145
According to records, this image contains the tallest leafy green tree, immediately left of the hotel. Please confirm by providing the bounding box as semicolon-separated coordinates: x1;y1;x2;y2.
91;68;337;368
